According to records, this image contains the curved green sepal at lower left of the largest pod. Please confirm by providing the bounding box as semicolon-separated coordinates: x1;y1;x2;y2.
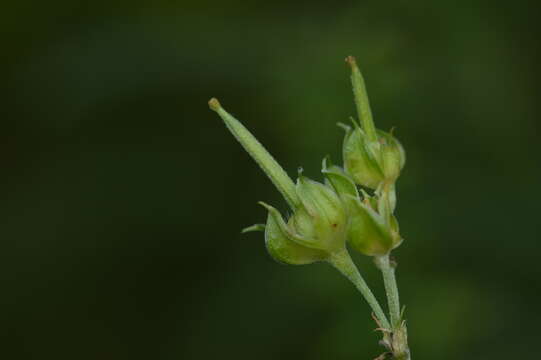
260;202;328;265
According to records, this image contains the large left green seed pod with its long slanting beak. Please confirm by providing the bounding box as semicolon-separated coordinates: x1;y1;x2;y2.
209;99;348;264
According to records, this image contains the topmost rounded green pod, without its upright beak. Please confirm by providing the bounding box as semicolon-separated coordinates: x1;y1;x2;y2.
342;126;406;189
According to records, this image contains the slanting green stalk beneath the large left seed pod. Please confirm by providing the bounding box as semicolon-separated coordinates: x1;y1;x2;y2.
328;249;391;330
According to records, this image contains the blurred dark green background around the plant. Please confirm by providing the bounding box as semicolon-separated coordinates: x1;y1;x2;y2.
0;0;541;360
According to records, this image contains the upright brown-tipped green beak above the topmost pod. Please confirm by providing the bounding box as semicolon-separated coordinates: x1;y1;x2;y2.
346;56;378;142
